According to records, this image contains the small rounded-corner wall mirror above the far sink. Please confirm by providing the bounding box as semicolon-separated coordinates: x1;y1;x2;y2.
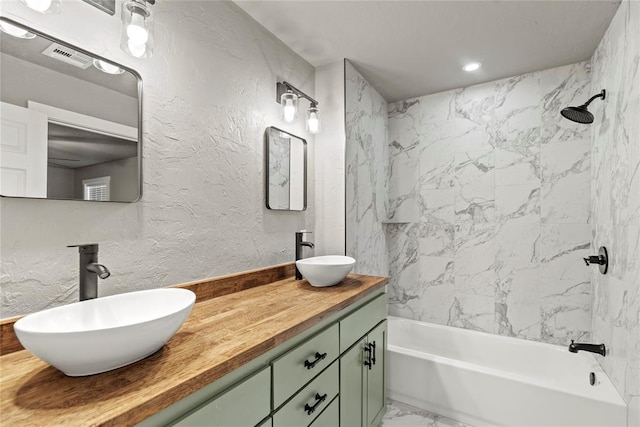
265;127;307;211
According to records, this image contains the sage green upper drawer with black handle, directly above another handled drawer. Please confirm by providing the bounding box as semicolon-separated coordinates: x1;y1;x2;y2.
273;323;340;408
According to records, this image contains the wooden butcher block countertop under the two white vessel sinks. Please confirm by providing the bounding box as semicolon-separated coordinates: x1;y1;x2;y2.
0;264;387;426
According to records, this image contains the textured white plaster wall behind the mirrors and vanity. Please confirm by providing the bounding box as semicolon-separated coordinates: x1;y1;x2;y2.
0;0;315;317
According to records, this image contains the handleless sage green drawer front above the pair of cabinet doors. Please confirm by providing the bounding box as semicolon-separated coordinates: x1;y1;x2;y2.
340;293;387;353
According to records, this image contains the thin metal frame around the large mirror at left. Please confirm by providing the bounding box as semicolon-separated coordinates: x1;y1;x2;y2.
0;15;142;203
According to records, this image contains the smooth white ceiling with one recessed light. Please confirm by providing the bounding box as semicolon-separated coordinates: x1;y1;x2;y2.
235;0;620;101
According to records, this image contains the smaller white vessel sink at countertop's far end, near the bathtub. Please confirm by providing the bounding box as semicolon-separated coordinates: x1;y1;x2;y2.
296;255;356;287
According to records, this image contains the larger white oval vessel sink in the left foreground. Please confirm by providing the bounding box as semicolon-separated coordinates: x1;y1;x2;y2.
13;288;196;377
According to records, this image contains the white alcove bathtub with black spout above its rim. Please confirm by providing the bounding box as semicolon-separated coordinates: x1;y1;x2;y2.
388;316;626;427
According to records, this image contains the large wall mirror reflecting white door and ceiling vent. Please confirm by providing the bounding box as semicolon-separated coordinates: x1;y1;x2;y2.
0;17;142;202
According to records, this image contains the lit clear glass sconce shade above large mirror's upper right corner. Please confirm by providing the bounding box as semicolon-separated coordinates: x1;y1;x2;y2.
120;0;156;58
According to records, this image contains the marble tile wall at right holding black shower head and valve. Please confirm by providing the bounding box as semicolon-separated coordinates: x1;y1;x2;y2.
591;1;640;410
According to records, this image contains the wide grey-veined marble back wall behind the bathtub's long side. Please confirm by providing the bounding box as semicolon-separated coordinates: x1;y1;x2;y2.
386;63;591;344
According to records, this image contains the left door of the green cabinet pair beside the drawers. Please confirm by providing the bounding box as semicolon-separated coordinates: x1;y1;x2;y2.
340;338;366;427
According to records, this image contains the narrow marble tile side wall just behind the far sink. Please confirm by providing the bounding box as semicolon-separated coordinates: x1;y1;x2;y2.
345;61;389;276
